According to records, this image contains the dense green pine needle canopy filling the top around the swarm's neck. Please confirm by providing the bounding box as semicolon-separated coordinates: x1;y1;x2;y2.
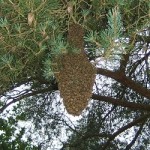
0;0;149;84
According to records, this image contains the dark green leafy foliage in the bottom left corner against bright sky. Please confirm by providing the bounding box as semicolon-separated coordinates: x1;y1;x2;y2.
0;117;38;150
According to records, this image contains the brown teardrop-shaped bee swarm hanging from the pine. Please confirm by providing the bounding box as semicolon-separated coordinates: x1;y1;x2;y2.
56;24;96;115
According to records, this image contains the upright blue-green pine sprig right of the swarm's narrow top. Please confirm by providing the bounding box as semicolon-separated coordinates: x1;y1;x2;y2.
85;7;125;58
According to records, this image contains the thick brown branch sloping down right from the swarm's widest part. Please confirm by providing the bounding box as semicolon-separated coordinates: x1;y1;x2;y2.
97;68;150;99
